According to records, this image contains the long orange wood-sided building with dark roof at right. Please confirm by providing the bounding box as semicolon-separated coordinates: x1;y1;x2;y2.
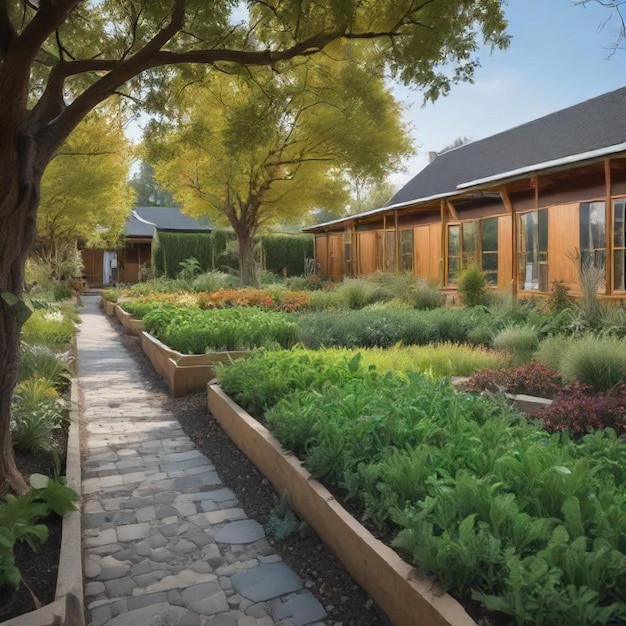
304;87;626;299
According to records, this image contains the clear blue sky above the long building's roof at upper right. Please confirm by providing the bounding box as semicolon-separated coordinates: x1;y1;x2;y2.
391;0;626;186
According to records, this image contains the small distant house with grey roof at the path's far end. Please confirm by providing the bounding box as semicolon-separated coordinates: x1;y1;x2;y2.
81;207;211;285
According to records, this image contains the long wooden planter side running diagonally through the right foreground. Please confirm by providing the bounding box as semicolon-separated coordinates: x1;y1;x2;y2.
207;381;475;626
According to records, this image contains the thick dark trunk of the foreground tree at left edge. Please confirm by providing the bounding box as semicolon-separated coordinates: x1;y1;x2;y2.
0;176;39;493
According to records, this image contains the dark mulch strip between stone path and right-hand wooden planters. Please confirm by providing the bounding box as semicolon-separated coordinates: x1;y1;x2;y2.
115;324;390;626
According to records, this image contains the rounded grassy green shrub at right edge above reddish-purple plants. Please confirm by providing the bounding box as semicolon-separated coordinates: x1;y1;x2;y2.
560;335;626;391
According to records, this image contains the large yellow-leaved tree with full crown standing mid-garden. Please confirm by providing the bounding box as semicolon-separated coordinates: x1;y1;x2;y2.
148;43;411;286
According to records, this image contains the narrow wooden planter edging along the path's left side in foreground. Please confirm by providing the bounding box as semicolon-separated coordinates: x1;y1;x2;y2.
2;380;85;626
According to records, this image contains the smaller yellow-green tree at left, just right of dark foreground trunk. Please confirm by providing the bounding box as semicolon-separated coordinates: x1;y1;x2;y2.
37;111;132;278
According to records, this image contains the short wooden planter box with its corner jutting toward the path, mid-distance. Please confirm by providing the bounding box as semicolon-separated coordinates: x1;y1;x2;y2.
139;331;249;398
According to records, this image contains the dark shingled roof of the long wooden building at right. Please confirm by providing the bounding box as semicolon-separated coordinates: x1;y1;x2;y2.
386;87;626;206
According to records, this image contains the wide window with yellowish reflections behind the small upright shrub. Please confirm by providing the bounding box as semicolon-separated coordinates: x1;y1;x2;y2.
448;217;498;285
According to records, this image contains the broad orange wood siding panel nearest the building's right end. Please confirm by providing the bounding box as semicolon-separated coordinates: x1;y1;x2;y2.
548;203;580;293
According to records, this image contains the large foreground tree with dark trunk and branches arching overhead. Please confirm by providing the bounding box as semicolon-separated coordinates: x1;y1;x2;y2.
0;0;507;490
